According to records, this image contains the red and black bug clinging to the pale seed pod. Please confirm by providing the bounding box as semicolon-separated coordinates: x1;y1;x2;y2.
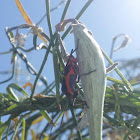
62;49;79;106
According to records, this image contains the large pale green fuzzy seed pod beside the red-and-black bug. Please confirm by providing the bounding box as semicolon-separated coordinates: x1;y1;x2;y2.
71;23;106;140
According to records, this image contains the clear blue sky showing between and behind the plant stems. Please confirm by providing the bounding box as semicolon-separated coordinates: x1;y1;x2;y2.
0;0;140;92
